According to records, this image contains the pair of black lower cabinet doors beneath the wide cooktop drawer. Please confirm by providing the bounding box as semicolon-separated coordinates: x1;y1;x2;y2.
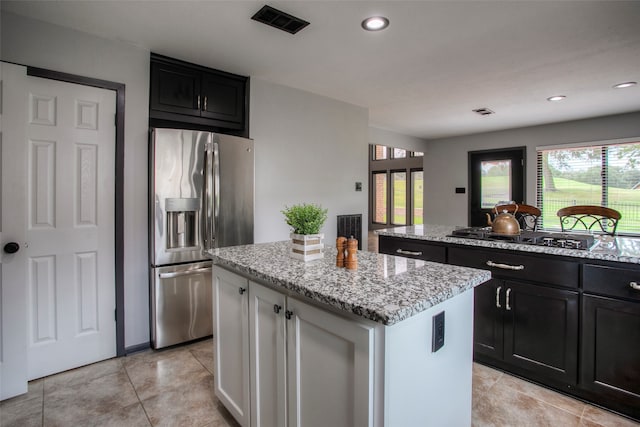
473;279;579;385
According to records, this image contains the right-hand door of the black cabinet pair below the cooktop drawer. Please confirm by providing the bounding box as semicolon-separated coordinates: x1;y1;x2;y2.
504;281;578;384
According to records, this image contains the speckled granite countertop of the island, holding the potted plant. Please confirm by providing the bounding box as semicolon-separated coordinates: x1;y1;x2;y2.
209;241;491;325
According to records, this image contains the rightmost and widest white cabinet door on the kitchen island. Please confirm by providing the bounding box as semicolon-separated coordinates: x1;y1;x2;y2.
287;298;374;427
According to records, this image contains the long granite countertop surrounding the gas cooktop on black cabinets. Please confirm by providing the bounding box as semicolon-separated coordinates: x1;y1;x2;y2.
376;224;640;264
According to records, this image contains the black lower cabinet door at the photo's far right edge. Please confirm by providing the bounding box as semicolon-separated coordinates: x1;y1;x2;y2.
580;294;640;419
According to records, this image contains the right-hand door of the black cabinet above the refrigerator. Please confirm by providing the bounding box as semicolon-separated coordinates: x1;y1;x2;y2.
201;73;246;129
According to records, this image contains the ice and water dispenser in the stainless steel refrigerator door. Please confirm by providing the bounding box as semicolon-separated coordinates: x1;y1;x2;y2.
165;198;200;250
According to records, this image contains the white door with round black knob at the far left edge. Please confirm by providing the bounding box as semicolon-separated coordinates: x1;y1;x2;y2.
0;62;27;400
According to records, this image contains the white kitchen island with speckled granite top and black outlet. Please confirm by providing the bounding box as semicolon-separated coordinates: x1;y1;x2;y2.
211;242;490;427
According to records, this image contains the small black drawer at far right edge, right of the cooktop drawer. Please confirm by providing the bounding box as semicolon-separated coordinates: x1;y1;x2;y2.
582;264;640;301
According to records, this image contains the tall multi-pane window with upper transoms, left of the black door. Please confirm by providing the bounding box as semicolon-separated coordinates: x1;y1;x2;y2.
369;145;423;228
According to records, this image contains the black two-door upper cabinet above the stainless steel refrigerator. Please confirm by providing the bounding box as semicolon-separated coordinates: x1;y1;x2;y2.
149;54;249;136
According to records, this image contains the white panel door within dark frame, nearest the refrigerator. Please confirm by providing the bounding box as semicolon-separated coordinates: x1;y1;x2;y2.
3;64;116;379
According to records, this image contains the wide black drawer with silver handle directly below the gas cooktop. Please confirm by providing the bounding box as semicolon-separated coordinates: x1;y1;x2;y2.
449;247;580;288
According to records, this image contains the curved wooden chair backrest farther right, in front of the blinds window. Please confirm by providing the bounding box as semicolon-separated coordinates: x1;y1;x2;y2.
557;205;622;236
